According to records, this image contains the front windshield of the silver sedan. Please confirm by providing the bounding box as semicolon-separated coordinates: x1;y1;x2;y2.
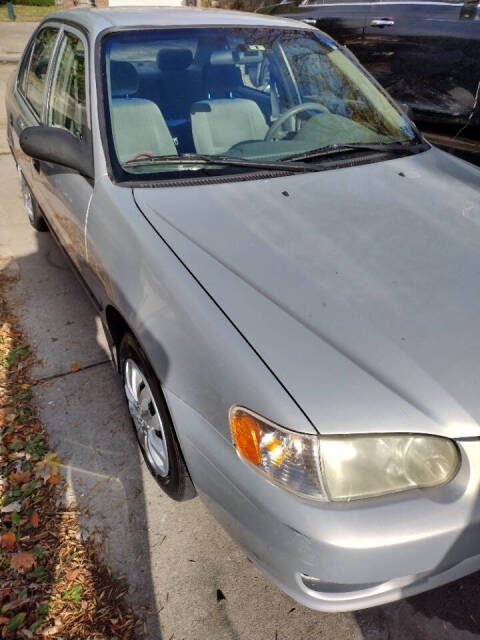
102;27;417;179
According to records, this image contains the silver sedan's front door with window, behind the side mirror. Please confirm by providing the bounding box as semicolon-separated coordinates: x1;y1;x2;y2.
37;27;93;273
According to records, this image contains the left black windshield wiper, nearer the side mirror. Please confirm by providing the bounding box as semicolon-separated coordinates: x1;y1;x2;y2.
122;153;317;172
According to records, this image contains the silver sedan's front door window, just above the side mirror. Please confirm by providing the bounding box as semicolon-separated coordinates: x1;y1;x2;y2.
47;33;87;138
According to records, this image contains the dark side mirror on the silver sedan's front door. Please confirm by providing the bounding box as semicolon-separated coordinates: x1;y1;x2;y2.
20;126;94;180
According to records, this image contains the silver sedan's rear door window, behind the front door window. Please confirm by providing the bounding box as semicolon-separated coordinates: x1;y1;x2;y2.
21;27;58;117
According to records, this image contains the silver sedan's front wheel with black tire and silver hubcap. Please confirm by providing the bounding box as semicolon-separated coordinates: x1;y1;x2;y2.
119;333;196;501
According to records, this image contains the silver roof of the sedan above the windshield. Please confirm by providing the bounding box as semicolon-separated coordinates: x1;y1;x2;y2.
44;7;312;36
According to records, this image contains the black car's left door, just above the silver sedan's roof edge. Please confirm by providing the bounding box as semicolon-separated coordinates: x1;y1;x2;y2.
267;0;371;56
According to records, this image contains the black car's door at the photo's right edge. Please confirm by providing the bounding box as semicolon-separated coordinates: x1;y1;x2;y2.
360;0;480;133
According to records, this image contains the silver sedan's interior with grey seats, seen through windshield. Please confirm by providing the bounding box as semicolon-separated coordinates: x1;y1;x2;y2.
108;30;408;164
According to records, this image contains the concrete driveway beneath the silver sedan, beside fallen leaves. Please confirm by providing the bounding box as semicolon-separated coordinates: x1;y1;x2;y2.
0;58;480;640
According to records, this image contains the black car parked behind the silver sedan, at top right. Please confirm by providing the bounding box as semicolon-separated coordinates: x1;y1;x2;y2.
259;0;480;158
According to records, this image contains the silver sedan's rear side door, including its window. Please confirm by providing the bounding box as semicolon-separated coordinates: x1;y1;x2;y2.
8;24;60;199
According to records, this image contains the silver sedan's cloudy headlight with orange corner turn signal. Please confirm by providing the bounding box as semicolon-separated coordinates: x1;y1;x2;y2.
230;407;460;500
